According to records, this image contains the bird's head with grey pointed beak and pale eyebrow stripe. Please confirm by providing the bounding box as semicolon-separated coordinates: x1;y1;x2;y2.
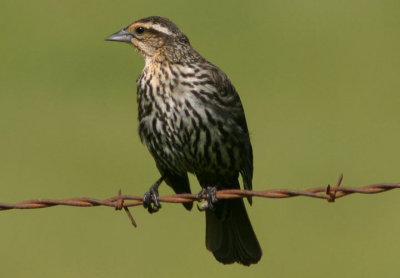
106;16;191;61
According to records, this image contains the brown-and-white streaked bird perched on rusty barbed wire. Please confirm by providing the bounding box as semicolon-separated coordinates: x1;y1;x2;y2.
106;16;262;266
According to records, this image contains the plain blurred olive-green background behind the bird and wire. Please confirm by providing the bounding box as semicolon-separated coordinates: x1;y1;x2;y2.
0;0;400;277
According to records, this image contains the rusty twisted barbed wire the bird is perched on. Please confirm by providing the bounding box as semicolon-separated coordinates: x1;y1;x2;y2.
0;174;400;227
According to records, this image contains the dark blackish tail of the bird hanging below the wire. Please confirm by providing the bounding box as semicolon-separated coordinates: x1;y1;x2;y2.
206;199;262;266
